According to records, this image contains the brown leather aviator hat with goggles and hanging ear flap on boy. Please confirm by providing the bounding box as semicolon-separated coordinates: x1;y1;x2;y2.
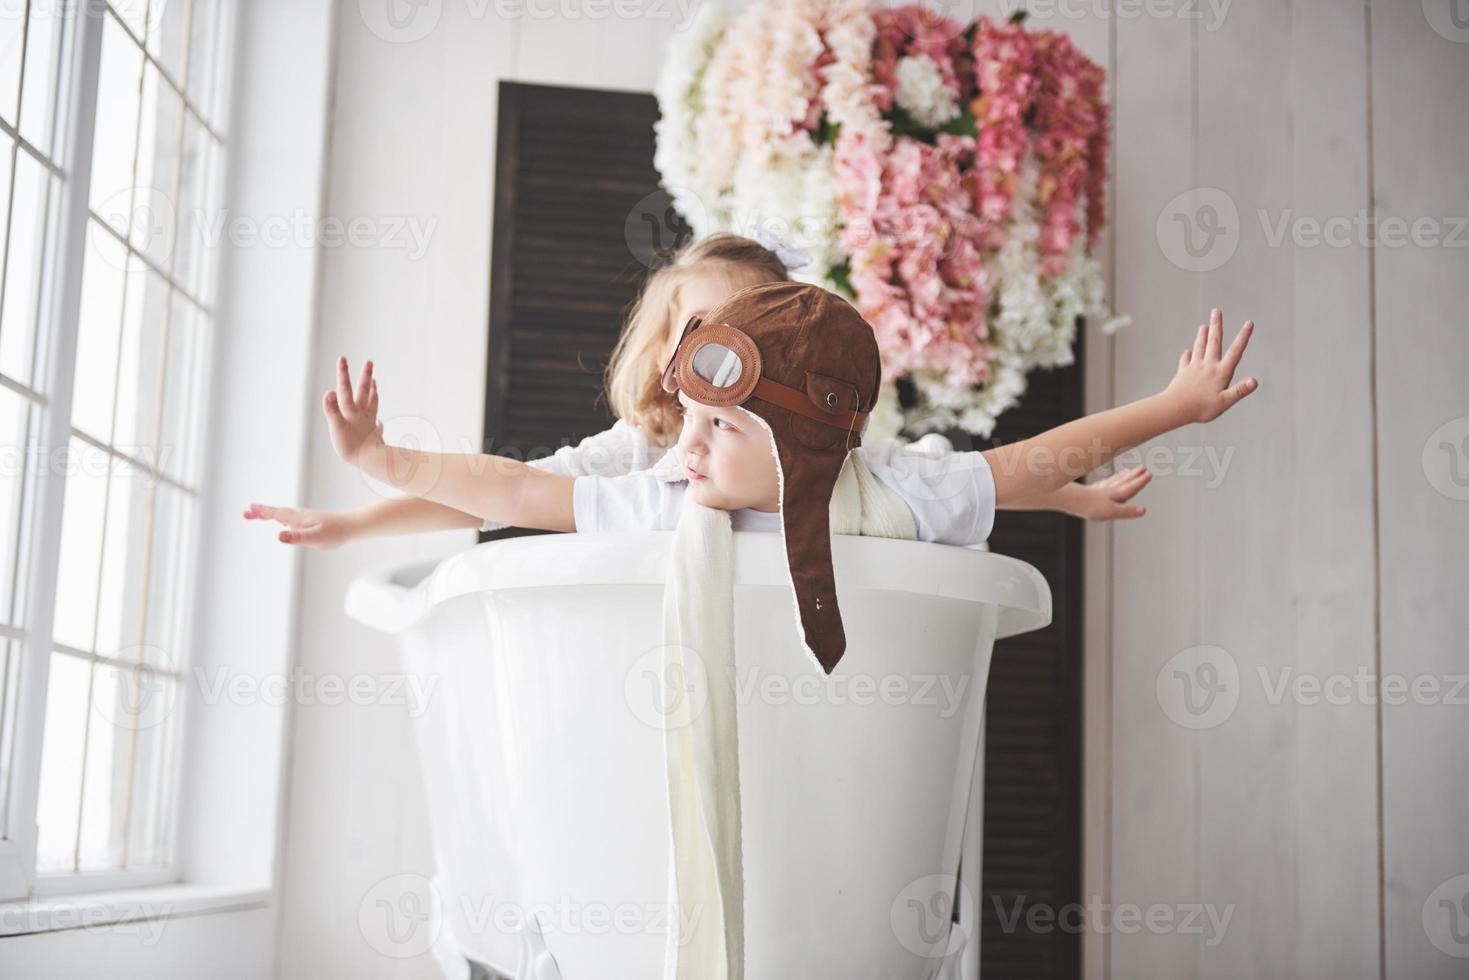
663;282;881;674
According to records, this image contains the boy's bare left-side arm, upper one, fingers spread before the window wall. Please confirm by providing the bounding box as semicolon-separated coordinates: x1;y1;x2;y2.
322;357;576;530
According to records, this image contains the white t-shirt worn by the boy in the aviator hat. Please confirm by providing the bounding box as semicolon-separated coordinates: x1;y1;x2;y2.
571;439;995;545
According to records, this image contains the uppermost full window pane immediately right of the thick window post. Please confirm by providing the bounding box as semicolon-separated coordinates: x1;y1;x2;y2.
88;16;142;235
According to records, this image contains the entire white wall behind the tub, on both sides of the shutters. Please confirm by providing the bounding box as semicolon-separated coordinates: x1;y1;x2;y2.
281;0;1469;980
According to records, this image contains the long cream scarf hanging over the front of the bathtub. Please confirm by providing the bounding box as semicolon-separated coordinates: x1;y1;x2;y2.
663;450;918;980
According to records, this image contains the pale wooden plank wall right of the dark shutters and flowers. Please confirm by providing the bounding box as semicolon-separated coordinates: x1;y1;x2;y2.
1087;0;1469;980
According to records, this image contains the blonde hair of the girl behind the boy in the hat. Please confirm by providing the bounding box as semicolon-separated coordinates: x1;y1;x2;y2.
607;232;790;442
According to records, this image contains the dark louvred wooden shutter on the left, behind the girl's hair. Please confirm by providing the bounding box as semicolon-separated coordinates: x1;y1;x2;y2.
480;82;687;541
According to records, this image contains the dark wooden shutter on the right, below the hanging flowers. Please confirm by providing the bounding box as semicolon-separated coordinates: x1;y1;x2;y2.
946;328;1086;980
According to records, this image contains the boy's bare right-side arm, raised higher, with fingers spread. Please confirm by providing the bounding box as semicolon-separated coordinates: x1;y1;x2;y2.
984;309;1259;502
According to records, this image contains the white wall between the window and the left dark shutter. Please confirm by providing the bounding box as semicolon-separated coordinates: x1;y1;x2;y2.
281;0;677;980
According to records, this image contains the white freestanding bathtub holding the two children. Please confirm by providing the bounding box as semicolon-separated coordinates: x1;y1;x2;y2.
347;532;1050;980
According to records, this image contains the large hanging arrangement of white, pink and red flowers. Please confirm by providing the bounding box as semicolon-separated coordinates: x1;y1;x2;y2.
654;0;1125;436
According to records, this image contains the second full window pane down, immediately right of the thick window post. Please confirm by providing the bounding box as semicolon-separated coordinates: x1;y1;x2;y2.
72;219;129;442
